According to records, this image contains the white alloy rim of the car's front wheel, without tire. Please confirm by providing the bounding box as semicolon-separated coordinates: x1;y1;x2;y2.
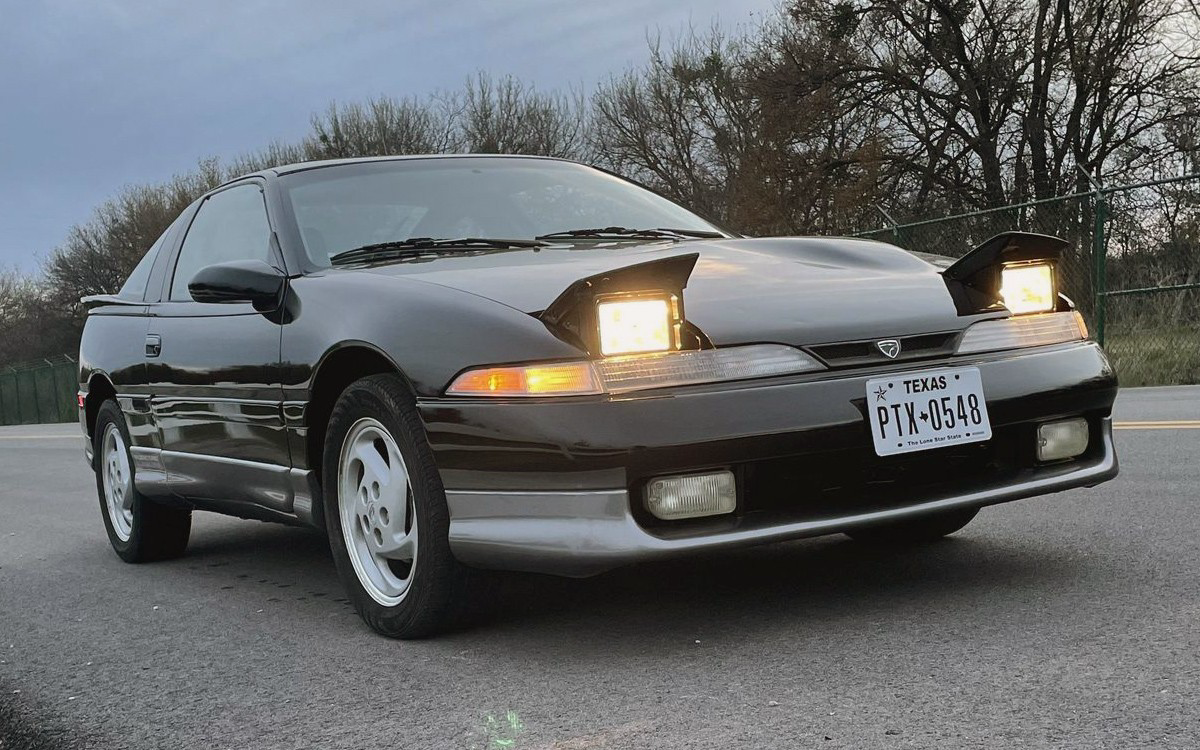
337;418;416;607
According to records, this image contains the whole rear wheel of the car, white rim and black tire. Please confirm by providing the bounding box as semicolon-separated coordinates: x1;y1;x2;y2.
92;400;192;563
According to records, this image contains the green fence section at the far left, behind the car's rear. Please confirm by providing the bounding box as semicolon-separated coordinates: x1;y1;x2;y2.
0;354;79;425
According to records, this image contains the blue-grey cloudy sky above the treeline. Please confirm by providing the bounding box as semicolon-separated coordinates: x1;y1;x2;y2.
0;0;775;271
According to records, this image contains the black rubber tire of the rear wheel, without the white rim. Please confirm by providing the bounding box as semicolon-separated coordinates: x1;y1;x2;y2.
92;398;192;563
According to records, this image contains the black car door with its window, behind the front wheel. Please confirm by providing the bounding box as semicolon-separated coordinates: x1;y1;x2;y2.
145;180;292;512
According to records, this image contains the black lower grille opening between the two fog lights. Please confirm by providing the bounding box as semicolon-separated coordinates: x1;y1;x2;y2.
742;425;1036;520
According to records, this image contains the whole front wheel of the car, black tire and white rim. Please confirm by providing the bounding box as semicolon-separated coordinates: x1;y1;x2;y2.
322;374;467;638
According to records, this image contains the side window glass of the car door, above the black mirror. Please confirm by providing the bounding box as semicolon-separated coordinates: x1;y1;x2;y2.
170;185;271;301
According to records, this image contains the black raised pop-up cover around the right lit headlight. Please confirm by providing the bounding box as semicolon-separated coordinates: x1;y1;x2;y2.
942;232;1070;316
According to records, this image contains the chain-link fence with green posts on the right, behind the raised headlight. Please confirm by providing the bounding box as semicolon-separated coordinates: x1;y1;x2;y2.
856;175;1200;385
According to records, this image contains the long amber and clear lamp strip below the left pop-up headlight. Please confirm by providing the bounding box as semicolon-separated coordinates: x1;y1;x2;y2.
446;343;824;396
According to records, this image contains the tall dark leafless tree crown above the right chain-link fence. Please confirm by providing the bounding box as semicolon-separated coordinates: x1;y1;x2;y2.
793;0;1200;212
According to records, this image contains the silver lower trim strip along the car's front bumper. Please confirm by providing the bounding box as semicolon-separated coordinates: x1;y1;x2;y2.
446;419;1117;577
